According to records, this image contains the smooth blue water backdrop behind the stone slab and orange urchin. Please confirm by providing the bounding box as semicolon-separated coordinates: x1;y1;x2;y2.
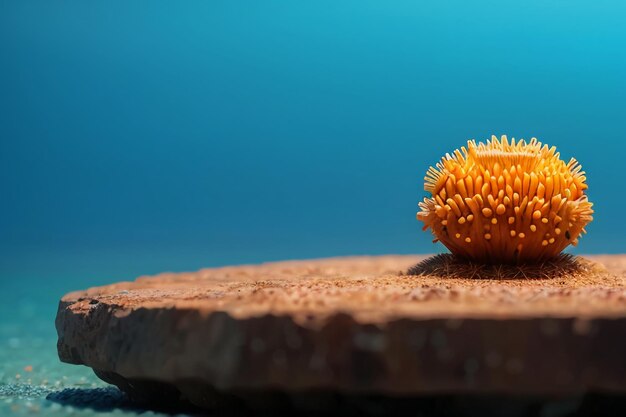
0;0;626;306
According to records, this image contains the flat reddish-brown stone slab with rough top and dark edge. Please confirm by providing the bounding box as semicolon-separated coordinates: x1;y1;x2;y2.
56;256;626;406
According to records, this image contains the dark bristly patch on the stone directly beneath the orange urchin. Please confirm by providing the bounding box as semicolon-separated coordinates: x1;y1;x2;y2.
406;253;599;279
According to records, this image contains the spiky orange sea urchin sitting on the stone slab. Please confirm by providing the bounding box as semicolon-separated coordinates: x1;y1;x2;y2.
417;136;593;263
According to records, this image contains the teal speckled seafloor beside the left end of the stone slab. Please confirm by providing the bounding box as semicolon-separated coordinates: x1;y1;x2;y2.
0;276;195;417
